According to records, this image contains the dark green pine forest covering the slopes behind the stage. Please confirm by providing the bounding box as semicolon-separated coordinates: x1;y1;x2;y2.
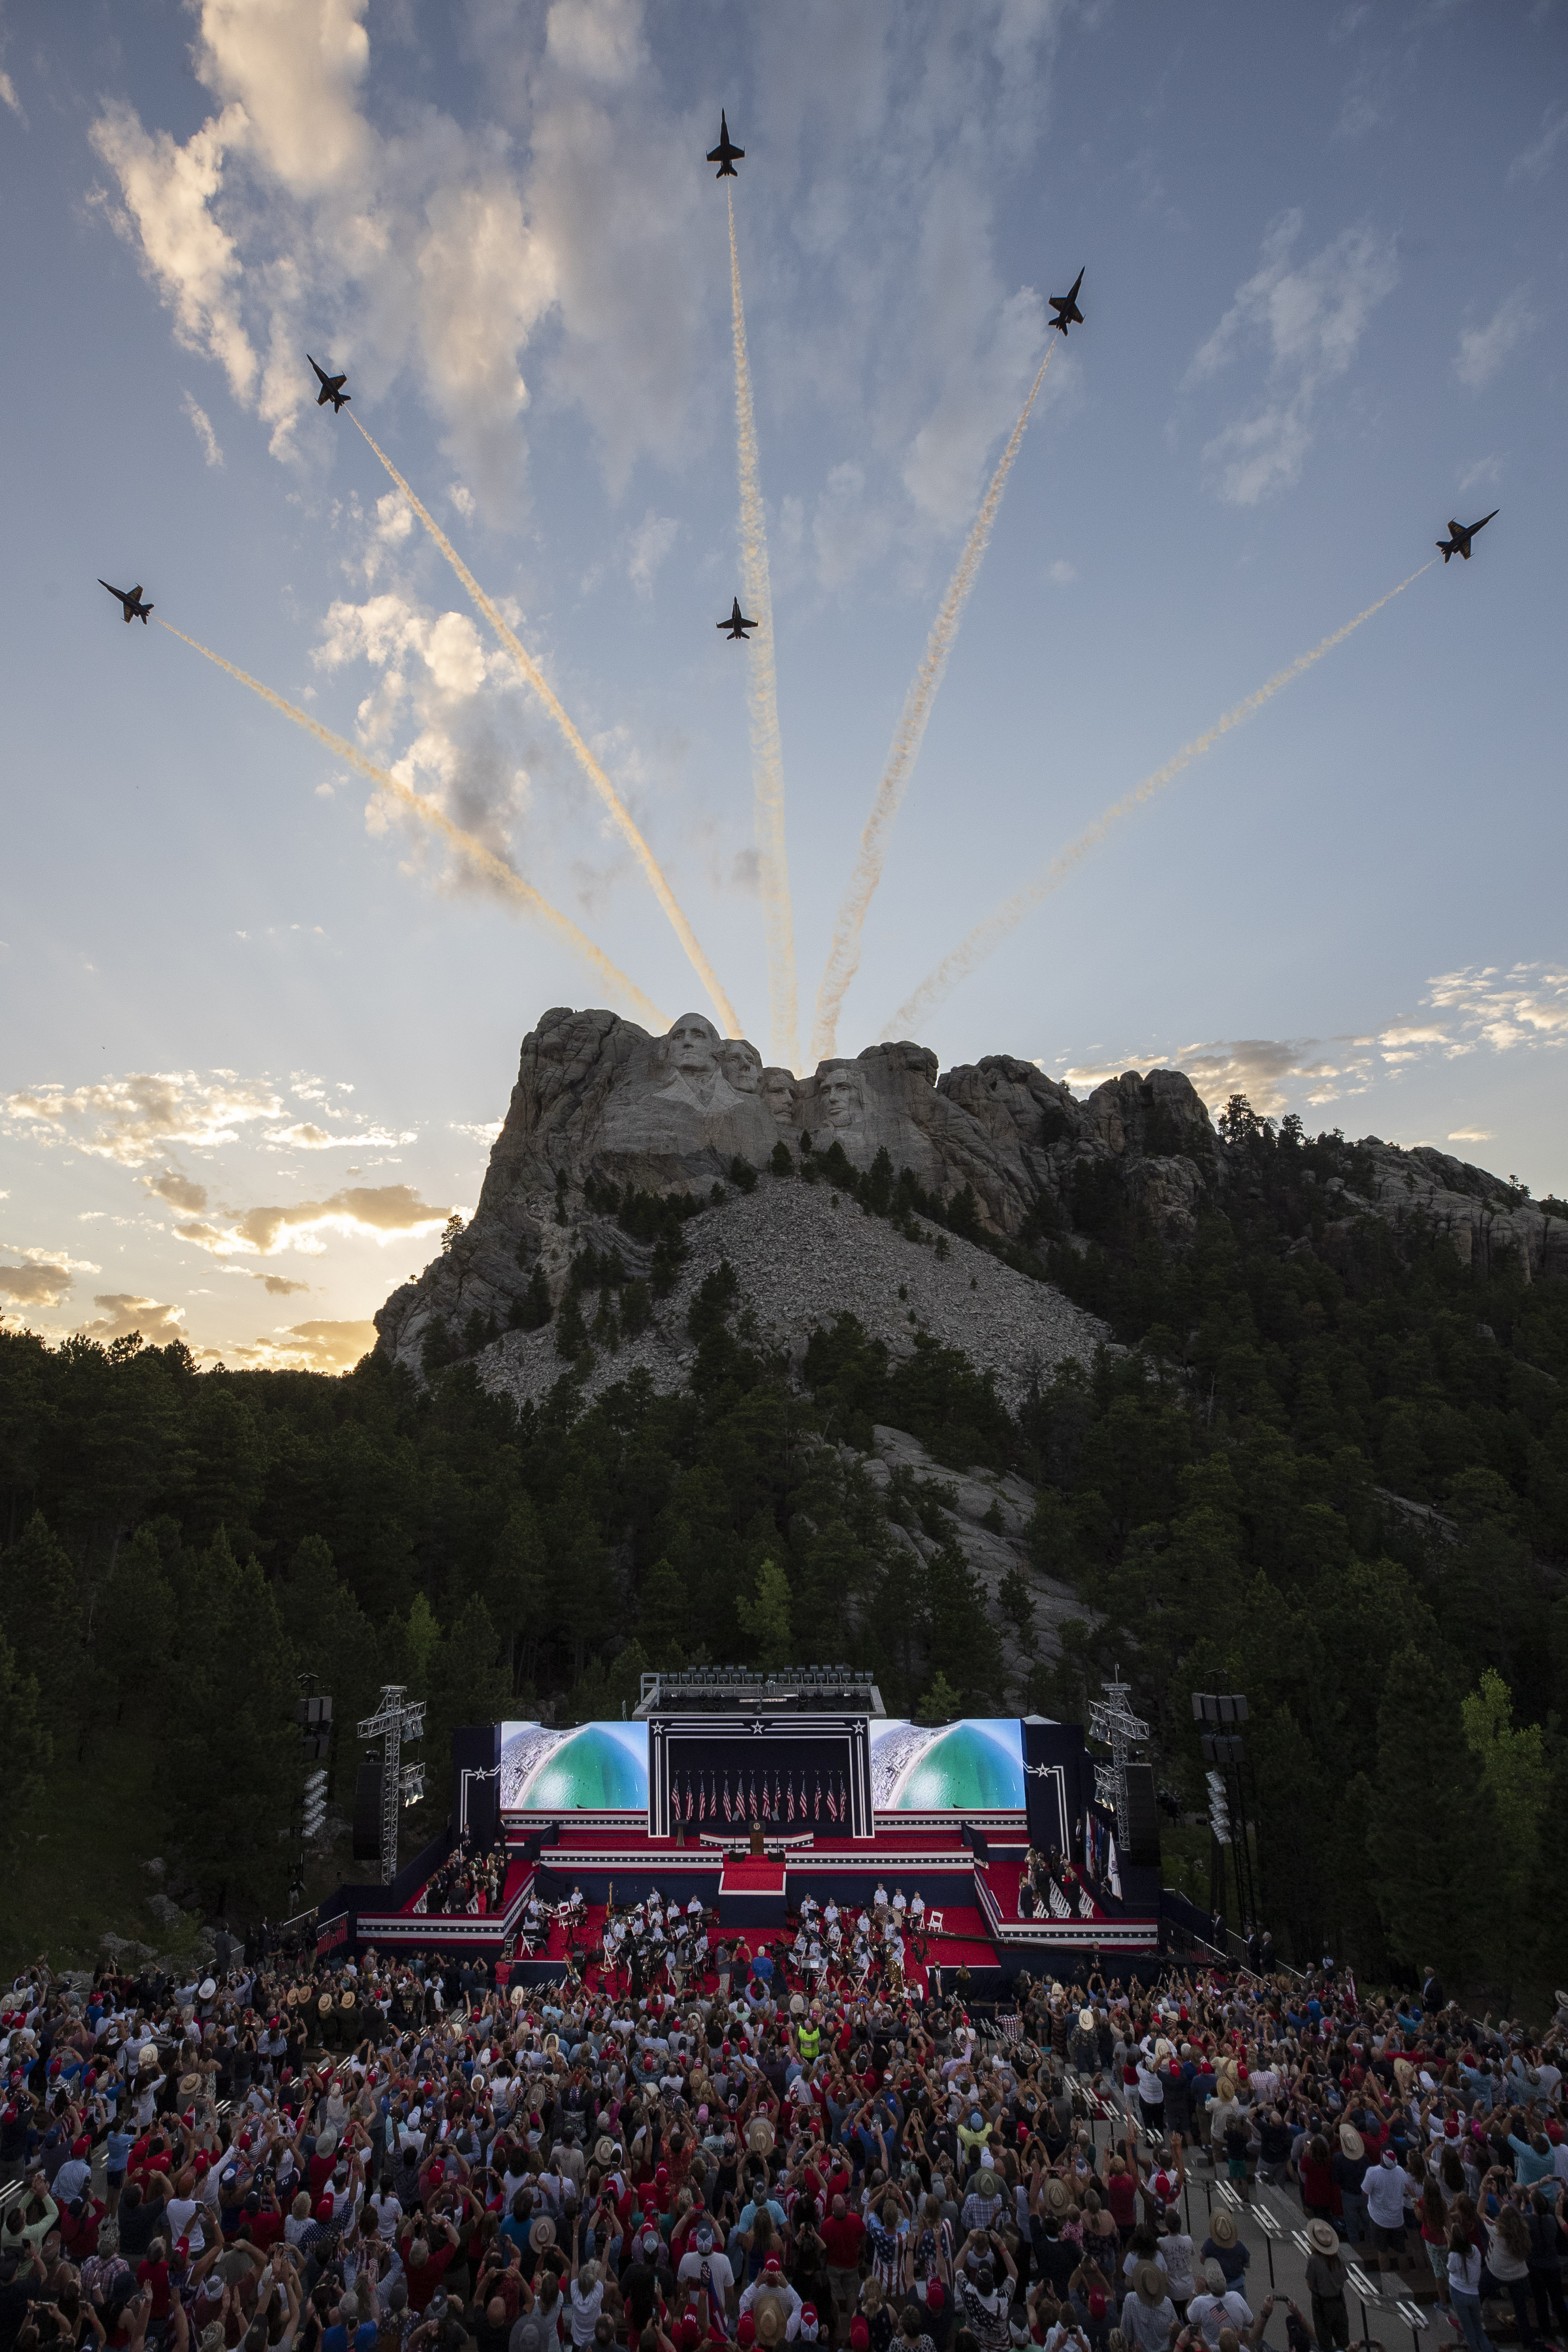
0;1103;1568;1997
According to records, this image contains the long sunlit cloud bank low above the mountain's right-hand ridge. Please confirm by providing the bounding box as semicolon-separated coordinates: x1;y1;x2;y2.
1060;965;1568;1124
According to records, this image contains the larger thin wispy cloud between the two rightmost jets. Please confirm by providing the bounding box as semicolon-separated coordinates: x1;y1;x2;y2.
1182;209;1399;506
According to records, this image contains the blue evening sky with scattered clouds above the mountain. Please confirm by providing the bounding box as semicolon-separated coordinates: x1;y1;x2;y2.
0;0;1568;1369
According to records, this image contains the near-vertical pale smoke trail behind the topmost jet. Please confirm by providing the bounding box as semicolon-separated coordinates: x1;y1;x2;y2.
724;188;797;1070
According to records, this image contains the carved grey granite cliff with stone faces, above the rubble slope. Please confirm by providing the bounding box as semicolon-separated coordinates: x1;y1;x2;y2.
376;1009;1218;1369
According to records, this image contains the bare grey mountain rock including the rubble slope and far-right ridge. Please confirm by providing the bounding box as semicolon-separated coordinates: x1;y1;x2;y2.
376;1009;1568;1395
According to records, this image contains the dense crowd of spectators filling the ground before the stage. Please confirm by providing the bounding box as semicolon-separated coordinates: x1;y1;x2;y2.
0;1929;1568;2352
